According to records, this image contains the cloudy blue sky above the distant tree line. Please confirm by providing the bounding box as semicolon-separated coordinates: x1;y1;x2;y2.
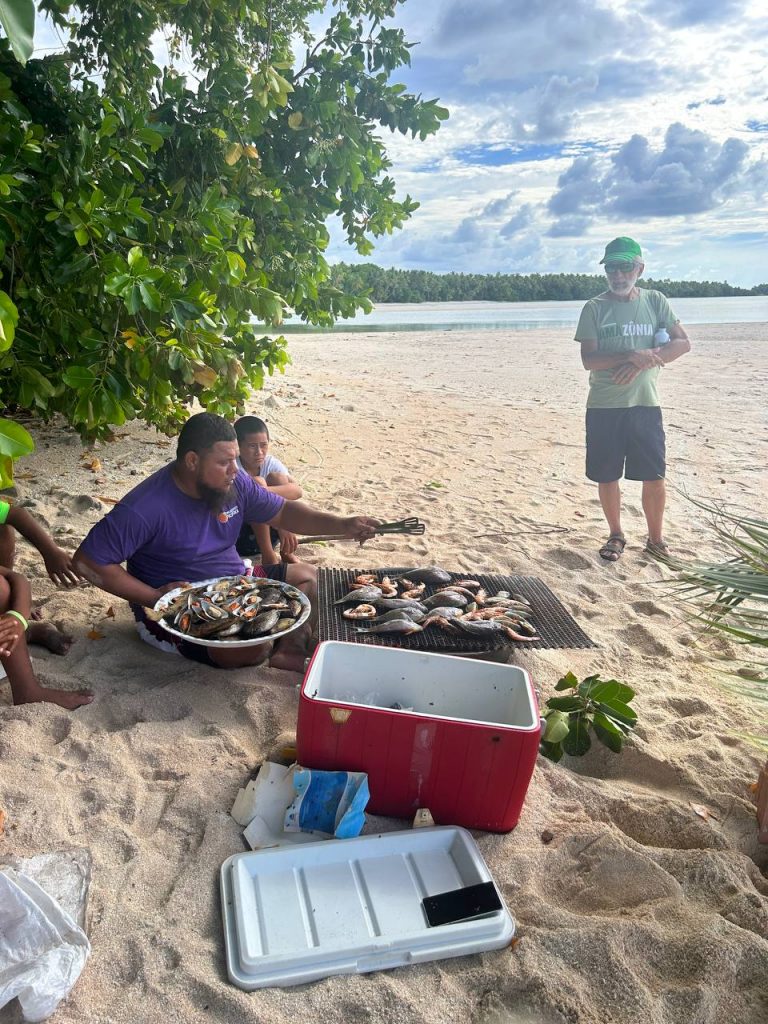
319;0;768;287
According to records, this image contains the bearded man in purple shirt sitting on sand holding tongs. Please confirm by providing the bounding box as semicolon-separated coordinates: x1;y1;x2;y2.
73;413;378;672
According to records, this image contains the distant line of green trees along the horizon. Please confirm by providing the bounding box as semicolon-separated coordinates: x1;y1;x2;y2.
331;263;768;302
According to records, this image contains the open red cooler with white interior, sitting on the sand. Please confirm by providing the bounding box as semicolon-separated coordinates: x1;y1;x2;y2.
297;641;541;831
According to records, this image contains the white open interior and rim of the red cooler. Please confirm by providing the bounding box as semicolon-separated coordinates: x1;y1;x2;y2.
303;640;540;731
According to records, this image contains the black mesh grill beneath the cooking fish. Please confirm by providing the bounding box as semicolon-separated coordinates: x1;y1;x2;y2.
317;566;597;654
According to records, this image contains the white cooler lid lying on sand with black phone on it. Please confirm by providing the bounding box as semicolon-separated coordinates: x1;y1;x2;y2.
221;826;515;990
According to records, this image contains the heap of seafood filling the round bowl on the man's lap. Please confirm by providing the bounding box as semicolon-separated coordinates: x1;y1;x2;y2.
146;575;305;640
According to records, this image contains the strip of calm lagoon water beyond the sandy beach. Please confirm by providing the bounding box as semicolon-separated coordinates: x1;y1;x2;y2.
283;295;768;334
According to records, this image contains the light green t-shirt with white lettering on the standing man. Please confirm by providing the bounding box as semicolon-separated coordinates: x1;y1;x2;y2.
575;288;680;409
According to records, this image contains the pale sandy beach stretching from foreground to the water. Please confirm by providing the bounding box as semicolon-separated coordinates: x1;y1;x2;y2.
0;324;768;1024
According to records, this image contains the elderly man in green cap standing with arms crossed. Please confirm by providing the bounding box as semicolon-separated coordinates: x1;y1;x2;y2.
575;238;690;562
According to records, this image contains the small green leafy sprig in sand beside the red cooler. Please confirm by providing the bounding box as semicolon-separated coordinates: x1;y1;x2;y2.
540;672;637;762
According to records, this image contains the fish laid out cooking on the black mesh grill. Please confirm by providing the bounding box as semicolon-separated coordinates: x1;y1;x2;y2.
335;565;540;640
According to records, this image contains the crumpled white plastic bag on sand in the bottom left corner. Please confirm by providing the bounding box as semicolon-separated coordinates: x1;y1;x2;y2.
0;868;91;1021
